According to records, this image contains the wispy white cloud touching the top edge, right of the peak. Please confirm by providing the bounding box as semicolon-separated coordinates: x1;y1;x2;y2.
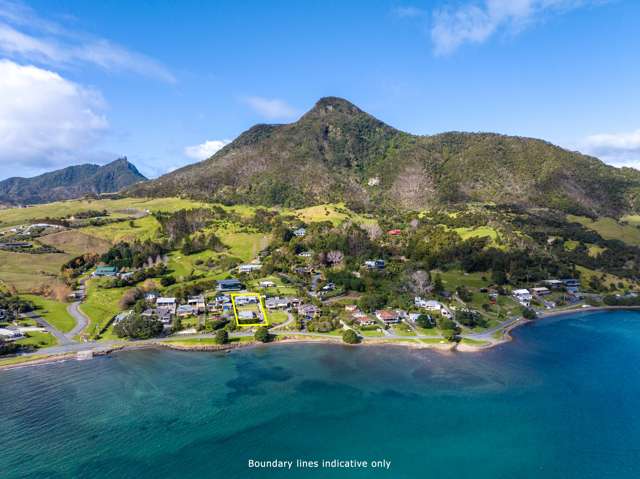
431;0;603;55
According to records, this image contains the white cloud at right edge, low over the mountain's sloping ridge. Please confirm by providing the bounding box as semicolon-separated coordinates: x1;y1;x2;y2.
580;129;640;168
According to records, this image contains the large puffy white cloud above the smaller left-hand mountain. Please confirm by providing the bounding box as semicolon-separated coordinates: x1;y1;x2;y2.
0;60;108;173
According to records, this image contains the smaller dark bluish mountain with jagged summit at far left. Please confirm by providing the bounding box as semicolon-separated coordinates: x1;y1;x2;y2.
0;158;146;205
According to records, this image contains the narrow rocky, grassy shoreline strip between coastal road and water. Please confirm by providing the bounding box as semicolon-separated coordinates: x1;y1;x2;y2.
5;306;640;371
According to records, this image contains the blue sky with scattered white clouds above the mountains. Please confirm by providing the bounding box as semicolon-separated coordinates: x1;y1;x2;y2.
0;0;640;180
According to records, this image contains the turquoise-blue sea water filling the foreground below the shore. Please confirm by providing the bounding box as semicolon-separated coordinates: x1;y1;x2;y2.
0;312;640;479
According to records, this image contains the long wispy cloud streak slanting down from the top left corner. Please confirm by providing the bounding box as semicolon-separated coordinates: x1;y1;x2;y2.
0;0;175;83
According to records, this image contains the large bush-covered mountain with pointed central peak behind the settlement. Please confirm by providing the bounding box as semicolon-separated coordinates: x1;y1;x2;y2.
130;97;640;216
